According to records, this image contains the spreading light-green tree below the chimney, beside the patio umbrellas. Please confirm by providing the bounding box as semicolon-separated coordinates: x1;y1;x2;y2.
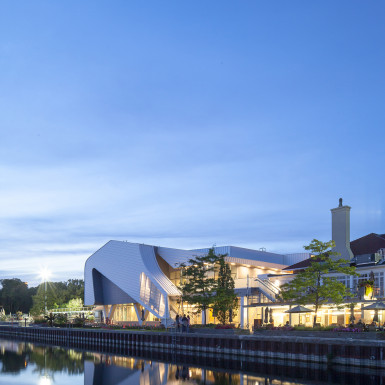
281;239;358;326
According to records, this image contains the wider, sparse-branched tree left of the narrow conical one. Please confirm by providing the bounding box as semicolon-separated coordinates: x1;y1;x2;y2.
178;248;217;324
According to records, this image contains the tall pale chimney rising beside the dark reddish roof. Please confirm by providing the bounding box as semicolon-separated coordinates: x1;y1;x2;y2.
330;198;354;261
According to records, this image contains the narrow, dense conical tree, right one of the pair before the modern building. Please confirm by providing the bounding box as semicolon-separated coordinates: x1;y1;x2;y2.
213;255;238;324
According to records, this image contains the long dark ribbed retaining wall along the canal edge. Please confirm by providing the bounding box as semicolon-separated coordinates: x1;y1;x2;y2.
0;326;385;368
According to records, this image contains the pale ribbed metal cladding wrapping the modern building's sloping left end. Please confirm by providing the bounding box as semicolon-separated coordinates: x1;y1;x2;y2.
84;241;172;316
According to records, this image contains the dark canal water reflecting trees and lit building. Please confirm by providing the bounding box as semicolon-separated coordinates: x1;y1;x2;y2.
0;340;385;385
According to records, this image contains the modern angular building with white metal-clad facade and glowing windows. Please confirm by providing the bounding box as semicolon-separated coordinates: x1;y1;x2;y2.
84;241;309;327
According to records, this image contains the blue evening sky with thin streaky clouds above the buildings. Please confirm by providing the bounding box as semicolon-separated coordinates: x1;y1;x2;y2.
0;0;385;284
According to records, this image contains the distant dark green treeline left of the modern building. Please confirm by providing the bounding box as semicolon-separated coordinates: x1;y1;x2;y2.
0;278;84;315
